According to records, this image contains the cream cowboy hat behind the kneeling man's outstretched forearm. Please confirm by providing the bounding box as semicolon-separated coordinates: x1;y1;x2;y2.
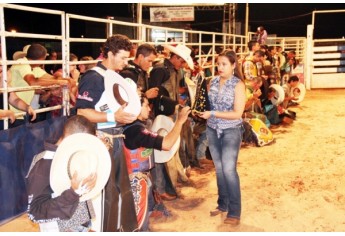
151;115;180;163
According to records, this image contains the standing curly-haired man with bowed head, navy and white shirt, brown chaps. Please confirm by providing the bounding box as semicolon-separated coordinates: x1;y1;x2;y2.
76;34;137;232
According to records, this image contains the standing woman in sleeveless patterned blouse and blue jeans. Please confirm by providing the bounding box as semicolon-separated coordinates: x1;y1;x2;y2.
199;50;246;225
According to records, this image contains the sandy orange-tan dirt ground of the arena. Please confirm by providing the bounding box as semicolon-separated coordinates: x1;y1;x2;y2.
0;89;345;232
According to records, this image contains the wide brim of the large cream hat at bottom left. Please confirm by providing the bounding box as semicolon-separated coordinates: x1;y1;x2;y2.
50;133;111;201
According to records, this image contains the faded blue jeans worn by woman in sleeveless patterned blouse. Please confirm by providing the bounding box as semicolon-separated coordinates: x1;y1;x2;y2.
206;124;244;219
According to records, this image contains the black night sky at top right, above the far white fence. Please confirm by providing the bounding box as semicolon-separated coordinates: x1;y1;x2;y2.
238;3;345;38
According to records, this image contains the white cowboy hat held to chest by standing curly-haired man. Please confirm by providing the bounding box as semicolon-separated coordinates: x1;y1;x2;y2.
104;70;141;116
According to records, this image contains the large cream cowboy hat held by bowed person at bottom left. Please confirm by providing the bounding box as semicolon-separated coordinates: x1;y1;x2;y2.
50;133;111;201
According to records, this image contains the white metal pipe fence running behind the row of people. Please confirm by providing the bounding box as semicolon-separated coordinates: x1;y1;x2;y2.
0;4;306;130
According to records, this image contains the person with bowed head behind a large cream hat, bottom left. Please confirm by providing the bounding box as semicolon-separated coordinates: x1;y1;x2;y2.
26;115;97;232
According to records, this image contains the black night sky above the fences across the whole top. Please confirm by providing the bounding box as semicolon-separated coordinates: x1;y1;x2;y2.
13;3;345;38
